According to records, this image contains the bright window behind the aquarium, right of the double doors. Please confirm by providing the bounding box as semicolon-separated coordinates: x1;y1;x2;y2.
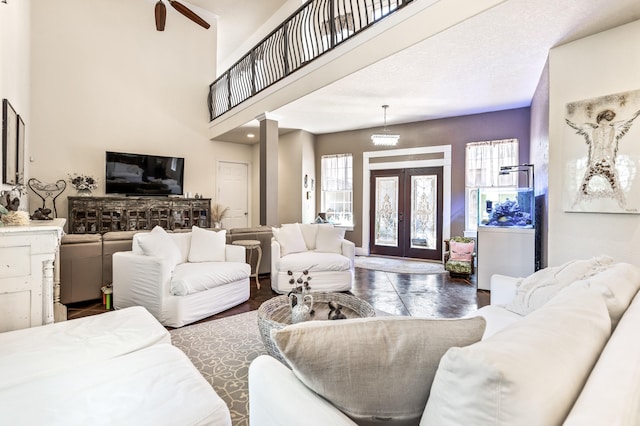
465;139;519;232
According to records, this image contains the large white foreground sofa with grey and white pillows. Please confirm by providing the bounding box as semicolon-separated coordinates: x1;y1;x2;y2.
249;257;640;426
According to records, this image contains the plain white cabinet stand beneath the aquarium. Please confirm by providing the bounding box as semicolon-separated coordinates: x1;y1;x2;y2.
476;227;536;290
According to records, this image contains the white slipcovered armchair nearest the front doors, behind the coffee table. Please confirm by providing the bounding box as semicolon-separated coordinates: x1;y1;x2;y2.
271;223;356;294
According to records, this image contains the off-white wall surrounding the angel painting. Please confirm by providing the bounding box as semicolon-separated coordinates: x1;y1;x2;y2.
549;21;640;266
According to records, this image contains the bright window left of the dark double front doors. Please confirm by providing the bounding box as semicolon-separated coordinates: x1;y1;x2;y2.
321;154;353;226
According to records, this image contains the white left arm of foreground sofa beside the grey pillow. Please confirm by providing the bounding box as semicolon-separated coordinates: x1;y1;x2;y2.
249;355;356;426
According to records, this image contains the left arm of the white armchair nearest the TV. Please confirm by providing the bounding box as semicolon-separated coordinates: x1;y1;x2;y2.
113;251;172;322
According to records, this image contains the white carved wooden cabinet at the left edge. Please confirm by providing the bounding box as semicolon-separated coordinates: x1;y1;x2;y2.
0;219;66;332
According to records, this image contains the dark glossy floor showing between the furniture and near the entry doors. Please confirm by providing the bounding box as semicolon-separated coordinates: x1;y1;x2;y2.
67;268;489;322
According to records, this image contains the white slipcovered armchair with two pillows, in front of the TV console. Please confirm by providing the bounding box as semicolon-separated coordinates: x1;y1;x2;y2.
113;226;251;327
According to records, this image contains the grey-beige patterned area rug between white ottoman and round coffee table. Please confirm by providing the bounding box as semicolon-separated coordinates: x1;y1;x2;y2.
170;311;267;426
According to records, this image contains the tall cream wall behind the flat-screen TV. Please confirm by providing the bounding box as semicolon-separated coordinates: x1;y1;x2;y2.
28;0;216;225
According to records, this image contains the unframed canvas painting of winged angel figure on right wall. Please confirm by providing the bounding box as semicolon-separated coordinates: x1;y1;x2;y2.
562;90;640;214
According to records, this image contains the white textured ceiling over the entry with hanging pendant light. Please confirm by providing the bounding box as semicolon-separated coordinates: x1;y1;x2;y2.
192;0;640;143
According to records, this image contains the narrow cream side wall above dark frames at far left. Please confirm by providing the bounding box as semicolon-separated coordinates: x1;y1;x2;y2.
0;0;31;196
